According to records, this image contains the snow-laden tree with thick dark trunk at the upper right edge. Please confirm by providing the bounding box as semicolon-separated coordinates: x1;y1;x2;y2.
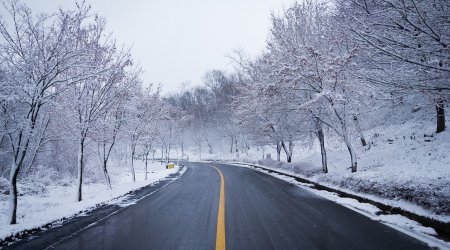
336;0;450;133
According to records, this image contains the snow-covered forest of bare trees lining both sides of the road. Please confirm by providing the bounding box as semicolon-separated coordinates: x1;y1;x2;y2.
0;0;450;230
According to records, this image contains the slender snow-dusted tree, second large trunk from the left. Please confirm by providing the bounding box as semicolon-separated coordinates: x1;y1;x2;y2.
65;17;136;201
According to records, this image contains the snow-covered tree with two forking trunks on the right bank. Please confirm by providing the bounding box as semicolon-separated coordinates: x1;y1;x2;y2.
267;1;366;172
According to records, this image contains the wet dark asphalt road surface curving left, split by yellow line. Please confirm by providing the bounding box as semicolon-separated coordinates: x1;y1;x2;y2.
6;163;428;250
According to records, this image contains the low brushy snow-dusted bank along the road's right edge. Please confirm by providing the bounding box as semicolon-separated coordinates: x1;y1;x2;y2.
258;157;450;222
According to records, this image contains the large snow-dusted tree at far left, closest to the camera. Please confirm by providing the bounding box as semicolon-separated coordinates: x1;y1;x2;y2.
0;1;92;224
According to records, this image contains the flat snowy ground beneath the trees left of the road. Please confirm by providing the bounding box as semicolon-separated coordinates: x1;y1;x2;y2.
0;161;183;240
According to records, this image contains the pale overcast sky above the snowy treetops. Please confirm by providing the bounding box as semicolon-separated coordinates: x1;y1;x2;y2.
23;0;294;93
